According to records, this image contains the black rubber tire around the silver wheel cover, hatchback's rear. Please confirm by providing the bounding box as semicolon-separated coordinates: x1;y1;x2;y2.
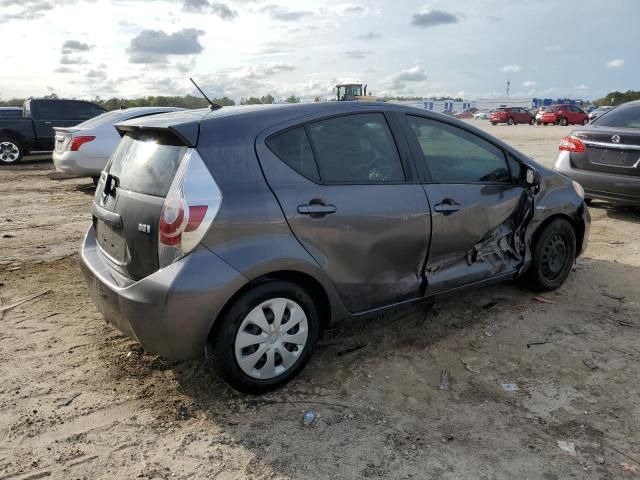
205;280;320;394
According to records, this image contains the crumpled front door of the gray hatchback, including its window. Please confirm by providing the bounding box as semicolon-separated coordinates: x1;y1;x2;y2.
406;115;527;295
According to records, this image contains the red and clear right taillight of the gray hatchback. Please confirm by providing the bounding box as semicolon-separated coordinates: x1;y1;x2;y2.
158;149;222;268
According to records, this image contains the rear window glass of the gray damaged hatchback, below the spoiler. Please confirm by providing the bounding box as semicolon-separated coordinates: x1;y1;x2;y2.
107;132;188;197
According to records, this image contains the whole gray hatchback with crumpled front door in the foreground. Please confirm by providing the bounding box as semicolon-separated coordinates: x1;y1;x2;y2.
81;102;590;393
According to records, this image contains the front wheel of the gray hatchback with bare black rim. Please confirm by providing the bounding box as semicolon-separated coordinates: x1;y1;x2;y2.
525;218;576;292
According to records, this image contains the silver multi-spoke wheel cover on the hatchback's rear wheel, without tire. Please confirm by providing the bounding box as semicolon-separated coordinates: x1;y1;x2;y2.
234;298;309;380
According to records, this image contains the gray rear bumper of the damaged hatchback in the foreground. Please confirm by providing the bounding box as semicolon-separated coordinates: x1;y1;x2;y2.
80;228;248;360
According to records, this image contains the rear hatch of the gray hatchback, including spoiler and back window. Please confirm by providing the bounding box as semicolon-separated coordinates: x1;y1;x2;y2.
93;111;208;280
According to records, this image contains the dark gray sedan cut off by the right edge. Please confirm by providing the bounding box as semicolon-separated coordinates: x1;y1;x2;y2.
554;101;640;205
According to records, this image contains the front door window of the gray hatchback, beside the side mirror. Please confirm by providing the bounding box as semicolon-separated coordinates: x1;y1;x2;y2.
407;115;511;183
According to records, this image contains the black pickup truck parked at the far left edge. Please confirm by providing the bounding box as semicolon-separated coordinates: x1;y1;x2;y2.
0;99;105;165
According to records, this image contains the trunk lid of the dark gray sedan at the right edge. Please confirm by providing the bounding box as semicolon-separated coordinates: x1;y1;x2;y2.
571;126;640;176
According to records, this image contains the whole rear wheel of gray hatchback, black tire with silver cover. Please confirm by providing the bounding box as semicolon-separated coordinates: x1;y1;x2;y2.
206;280;320;394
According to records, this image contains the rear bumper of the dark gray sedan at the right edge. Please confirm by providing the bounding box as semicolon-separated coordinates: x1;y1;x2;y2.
553;152;640;206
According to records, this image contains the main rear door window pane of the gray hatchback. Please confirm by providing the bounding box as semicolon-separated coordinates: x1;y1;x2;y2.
307;113;405;183
